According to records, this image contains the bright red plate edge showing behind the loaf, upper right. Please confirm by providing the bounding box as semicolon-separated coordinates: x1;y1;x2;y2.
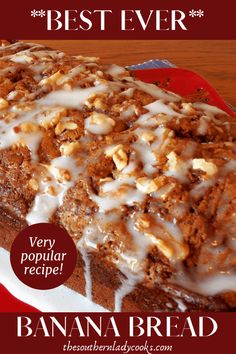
131;68;236;117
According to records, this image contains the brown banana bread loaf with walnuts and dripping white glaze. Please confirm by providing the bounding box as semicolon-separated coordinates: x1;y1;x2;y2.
0;41;236;311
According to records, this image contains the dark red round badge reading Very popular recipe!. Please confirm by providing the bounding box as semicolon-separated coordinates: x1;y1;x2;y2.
10;223;77;290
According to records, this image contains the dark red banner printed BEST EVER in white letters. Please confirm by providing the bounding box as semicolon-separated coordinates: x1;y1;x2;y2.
0;0;236;39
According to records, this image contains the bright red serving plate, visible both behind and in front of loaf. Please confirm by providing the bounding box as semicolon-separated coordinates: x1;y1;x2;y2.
0;68;236;312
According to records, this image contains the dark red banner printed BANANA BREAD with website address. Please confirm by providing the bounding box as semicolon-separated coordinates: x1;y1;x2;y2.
0;313;236;354
